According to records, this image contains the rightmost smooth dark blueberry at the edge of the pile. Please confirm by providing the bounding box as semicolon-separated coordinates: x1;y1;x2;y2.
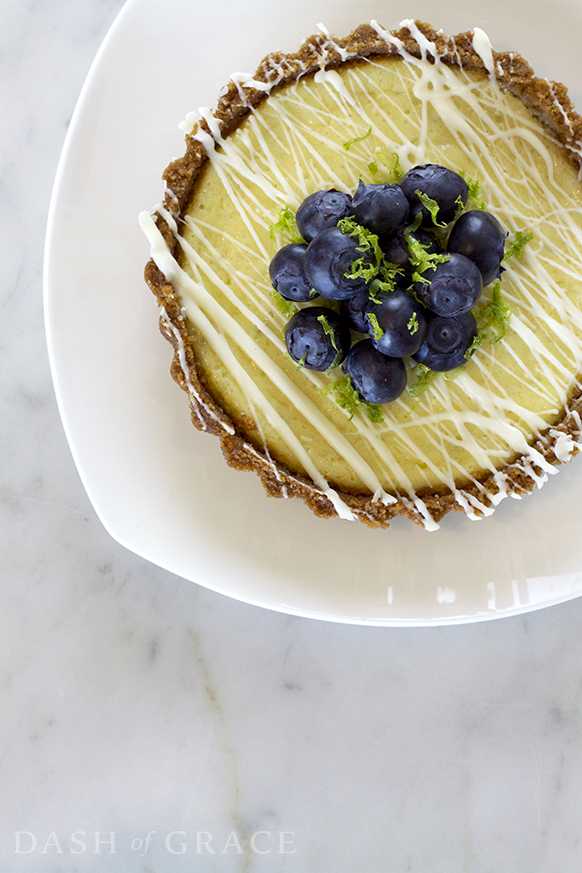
447;209;507;285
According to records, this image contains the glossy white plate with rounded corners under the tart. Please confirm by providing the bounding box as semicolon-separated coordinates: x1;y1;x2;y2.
45;0;582;625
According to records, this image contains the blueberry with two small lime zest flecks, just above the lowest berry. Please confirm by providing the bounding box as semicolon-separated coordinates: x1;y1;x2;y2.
367;288;426;358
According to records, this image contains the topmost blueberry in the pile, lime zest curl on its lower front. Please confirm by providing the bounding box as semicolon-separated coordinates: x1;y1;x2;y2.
399;164;468;227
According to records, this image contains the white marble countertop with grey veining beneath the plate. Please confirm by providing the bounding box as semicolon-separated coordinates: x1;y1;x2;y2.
0;0;582;873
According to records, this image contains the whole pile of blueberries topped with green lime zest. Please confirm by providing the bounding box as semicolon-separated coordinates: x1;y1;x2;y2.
269;164;507;404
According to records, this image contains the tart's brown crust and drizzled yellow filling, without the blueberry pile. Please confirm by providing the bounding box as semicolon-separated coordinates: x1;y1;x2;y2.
140;21;582;530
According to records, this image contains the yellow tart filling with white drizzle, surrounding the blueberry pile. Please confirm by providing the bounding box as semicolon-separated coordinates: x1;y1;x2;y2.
142;21;582;530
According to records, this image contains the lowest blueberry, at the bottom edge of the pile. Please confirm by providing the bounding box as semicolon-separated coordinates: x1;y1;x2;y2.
343;340;406;403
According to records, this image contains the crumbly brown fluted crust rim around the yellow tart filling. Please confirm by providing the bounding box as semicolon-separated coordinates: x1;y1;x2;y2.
144;21;582;527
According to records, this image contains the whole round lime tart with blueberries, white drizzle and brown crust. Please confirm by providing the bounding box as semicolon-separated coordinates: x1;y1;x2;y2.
140;21;582;530
